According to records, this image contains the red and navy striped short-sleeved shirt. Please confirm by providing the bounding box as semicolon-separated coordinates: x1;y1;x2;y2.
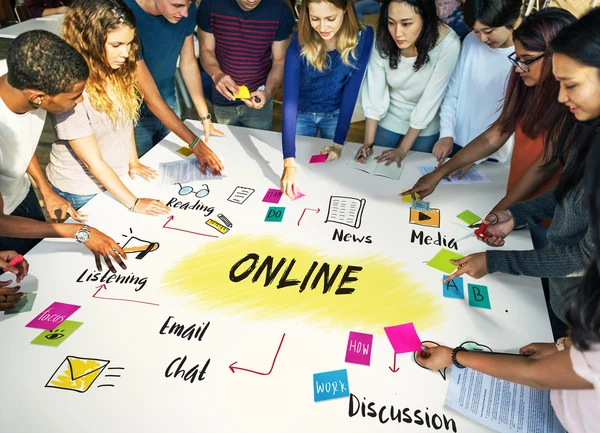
196;0;294;105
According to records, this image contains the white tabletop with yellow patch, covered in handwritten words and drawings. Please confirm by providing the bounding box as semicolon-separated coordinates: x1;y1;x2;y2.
0;122;552;433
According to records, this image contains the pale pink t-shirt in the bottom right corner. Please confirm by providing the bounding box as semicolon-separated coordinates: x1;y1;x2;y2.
551;344;600;433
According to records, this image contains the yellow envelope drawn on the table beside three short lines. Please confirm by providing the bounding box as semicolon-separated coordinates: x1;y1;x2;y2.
46;356;110;392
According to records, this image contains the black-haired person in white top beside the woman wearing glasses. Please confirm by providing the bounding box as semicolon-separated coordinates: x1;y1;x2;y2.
432;0;522;174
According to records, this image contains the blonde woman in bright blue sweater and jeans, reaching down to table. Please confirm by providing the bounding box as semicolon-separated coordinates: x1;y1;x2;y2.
281;0;373;197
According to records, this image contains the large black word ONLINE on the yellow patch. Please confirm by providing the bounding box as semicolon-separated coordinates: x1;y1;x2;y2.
229;253;362;295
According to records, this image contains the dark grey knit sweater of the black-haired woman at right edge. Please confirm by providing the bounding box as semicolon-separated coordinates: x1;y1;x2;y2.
486;188;594;322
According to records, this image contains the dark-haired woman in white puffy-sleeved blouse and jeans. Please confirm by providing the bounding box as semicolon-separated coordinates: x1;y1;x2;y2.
356;0;460;166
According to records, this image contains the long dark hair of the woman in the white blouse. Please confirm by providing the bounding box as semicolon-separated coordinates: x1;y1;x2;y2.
376;0;440;71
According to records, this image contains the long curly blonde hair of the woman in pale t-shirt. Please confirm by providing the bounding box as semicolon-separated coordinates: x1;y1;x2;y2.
62;0;142;126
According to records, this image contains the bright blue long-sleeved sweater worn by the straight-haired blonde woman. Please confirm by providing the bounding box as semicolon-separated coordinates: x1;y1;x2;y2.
282;27;373;158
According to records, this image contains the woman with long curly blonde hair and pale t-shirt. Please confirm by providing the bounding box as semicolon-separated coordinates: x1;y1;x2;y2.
46;0;169;215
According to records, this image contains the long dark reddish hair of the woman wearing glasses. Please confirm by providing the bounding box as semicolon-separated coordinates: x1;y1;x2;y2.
499;8;576;149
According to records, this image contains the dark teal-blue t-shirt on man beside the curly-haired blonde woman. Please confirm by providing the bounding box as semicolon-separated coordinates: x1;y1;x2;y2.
124;0;196;105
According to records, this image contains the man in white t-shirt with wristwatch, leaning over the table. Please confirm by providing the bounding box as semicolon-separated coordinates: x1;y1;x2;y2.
0;30;125;272
